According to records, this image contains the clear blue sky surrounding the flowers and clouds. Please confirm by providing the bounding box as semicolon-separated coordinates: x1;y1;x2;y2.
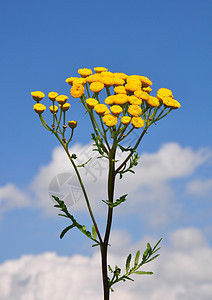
0;0;212;299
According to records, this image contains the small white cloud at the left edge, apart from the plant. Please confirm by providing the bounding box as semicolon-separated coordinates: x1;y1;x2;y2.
0;183;29;214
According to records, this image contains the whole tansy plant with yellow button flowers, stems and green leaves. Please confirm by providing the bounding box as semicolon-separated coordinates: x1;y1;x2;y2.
31;67;181;300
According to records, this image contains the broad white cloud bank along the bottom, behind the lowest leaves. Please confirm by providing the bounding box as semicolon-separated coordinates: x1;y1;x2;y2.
0;228;212;300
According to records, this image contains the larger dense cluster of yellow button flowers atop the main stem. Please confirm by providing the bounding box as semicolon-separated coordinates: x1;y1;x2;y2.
66;67;181;128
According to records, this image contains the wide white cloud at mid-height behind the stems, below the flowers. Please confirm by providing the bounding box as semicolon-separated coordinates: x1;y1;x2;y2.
31;143;212;226
